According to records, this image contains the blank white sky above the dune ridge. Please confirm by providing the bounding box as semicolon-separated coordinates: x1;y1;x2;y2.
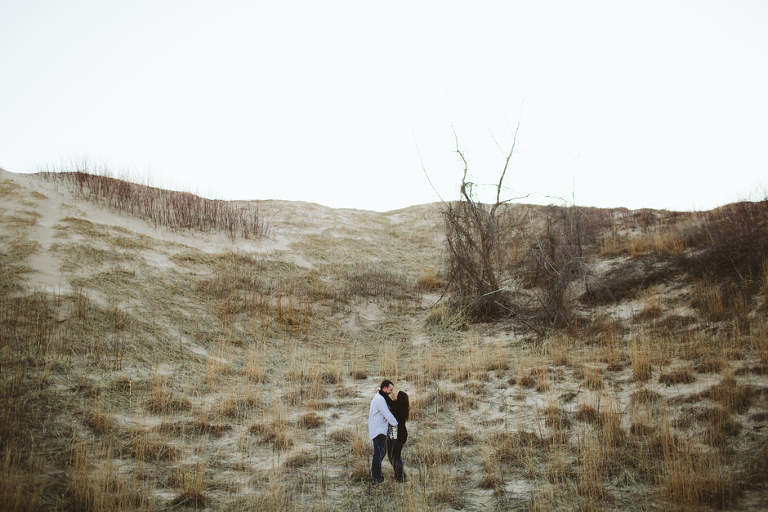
0;0;768;211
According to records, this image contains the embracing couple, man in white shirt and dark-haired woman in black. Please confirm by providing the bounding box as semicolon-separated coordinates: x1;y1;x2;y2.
368;380;410;483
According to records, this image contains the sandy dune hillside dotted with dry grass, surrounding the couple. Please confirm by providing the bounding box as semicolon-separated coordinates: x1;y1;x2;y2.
0;171;768;510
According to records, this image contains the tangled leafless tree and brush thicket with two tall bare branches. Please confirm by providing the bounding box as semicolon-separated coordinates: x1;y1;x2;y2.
444;130;587;327
